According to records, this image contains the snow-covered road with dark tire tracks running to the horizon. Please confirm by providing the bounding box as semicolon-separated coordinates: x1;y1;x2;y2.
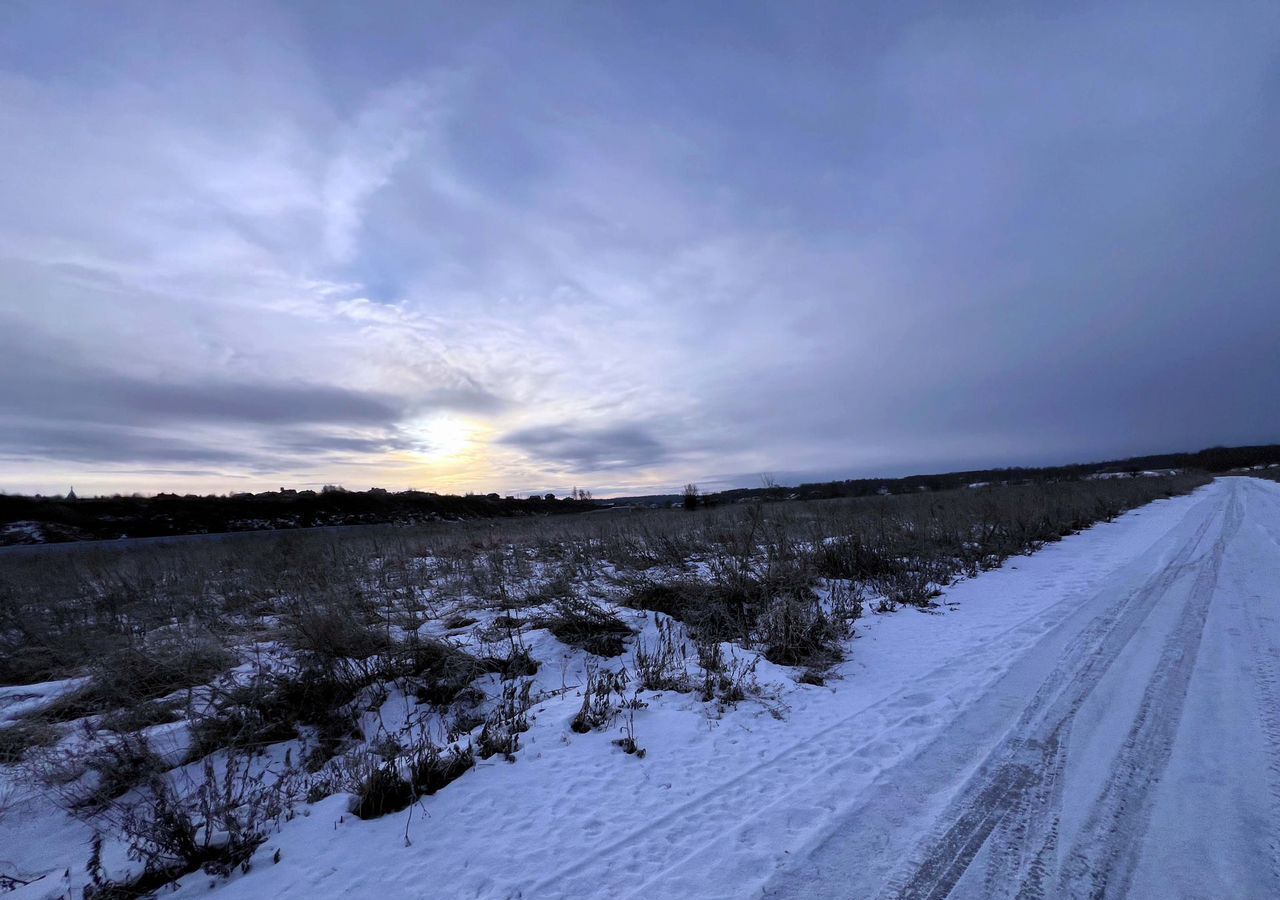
764;479;1280;897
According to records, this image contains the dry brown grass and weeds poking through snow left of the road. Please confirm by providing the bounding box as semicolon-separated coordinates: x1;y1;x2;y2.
0;475;1207;896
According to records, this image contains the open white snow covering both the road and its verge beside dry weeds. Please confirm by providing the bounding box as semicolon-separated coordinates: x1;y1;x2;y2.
0;479;1280;900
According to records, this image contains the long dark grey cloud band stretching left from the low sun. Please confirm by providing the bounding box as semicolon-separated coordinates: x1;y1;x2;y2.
0;330;483;474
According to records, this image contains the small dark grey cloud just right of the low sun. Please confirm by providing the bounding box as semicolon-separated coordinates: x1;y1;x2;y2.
498;425;669;472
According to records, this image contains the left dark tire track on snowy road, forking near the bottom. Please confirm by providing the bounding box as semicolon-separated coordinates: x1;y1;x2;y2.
881;492;1235;900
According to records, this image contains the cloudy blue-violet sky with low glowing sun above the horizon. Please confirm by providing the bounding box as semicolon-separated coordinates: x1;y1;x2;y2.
0;0;1280;495
